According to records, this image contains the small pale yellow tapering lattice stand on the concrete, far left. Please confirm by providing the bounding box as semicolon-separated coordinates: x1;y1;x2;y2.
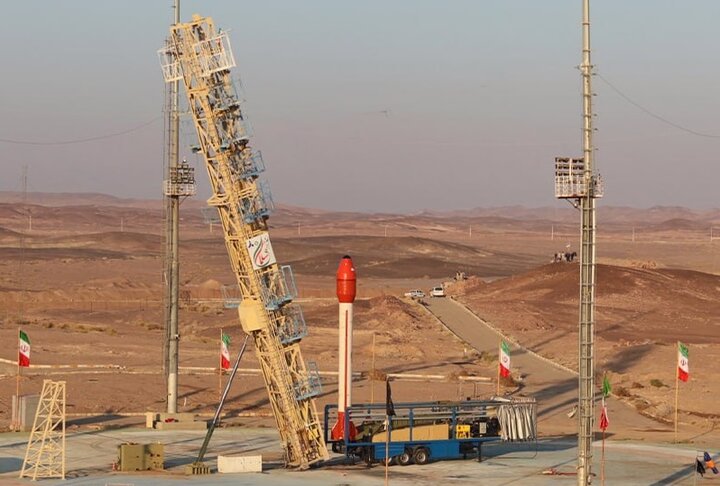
20;380;65;481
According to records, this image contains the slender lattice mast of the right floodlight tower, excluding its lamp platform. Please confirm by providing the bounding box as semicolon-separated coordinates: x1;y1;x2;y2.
577;0;596;486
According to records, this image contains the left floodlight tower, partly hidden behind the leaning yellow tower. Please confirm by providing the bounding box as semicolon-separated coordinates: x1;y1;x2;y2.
163;0;196;413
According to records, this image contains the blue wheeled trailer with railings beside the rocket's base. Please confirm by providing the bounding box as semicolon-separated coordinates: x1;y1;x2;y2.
324;399;537;466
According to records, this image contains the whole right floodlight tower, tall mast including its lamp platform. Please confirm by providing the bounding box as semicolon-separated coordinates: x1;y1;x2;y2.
555;0;603;486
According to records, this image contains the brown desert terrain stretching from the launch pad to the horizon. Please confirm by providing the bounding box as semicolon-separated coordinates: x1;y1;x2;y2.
0;193;720;446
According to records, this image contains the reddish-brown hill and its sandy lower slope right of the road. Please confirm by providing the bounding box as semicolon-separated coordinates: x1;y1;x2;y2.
453;263;720;421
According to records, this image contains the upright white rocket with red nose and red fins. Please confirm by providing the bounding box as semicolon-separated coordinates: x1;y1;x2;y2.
332;255;357;440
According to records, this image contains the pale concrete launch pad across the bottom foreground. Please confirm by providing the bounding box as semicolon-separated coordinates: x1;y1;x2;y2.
0;427;720;486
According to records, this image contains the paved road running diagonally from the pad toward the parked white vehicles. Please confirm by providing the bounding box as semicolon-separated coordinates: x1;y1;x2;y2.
425;298;672;440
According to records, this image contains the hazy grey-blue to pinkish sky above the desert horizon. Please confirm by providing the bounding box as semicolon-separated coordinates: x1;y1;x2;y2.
0;0;720;212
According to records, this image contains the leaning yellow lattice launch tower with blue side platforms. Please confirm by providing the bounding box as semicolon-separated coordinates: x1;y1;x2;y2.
159;15;328;469
